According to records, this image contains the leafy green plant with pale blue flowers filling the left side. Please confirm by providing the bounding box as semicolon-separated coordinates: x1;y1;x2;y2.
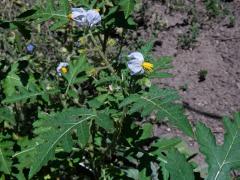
0;0;240;180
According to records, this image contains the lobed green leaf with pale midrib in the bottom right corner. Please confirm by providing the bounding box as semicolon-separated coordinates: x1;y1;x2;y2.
196;113;240;180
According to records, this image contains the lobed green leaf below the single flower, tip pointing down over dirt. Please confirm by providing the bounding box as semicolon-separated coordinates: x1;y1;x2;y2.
120;86;193;136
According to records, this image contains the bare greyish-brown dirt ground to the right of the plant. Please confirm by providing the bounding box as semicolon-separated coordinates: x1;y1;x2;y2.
135;0;240;175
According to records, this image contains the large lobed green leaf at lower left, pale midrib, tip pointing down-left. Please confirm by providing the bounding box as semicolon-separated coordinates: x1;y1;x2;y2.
29;108;113;177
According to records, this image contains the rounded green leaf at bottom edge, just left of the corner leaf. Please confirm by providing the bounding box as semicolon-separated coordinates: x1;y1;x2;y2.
165;149;194;180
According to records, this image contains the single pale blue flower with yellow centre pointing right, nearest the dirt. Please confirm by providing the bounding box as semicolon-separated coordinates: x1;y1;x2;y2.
128;52;153;75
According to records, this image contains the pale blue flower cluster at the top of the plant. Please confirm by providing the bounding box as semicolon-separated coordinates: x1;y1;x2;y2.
68;8;102;28
